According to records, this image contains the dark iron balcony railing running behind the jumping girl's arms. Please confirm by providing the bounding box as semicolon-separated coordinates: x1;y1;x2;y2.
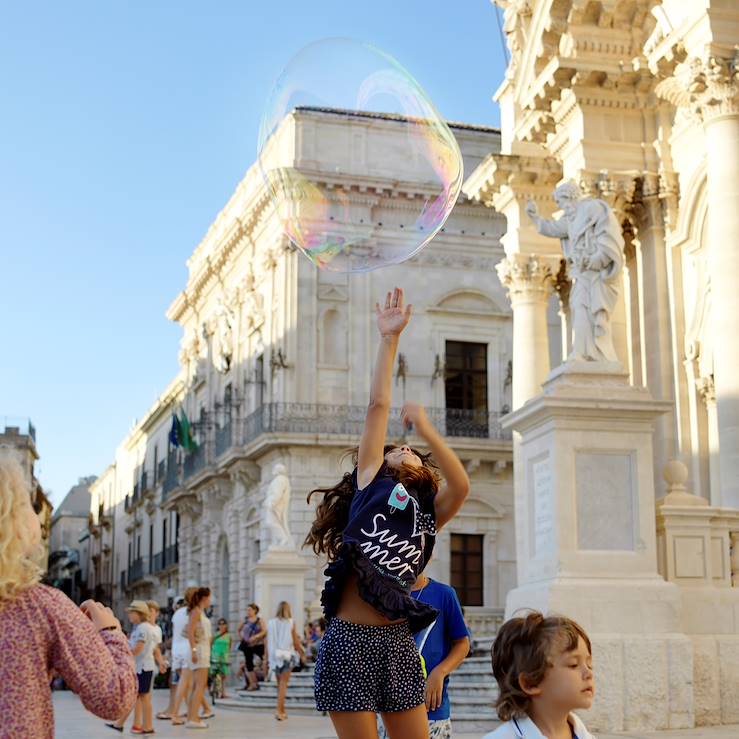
243;403;511;444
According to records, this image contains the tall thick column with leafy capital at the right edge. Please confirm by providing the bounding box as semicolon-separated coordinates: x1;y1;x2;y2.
657;50;739;508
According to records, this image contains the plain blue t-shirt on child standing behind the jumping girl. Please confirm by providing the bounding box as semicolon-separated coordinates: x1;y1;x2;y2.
411;578;470;721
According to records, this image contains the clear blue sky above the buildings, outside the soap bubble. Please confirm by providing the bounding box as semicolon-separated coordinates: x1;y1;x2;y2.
0;0;504;503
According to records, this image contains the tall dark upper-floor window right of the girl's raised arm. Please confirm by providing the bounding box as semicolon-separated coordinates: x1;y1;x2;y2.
444;341;488;438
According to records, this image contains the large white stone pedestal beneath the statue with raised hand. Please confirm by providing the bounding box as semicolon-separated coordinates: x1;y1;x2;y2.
503;362;694;731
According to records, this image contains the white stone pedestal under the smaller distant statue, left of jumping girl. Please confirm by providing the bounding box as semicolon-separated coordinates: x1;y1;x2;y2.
254;548;310;635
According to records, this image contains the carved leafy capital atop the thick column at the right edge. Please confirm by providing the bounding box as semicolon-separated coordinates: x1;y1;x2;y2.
656;47;739;123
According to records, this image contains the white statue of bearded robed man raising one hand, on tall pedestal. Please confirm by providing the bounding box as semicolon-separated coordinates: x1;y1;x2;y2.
526;182;624;362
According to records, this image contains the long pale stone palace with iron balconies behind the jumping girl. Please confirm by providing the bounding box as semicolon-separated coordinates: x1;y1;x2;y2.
91;110;515;633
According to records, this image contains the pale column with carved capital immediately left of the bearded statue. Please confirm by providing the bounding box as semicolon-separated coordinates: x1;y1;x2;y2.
497;254;558;410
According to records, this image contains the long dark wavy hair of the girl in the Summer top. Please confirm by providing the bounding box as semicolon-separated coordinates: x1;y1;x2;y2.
303;444;440;562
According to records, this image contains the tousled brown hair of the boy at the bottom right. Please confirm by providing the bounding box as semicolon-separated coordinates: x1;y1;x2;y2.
491;611;592;721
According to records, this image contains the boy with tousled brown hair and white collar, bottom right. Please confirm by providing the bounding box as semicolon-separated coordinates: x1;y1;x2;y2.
484;611;595;739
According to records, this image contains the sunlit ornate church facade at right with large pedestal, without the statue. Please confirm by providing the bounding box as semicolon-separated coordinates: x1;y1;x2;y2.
464;0;739;730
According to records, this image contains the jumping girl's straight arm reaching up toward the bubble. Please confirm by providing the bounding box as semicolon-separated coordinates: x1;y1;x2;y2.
357;287;413;490
